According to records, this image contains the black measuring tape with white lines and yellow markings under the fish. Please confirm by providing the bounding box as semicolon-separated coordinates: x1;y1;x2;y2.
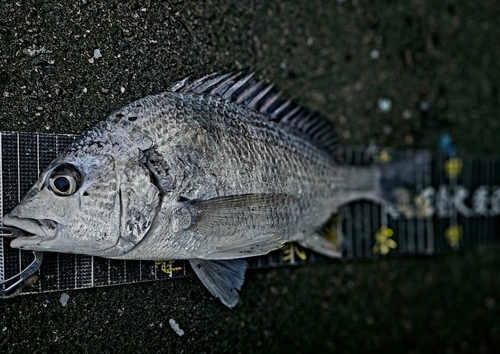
0;132;500;298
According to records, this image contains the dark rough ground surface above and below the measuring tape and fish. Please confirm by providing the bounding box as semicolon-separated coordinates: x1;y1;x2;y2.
0;0;500;353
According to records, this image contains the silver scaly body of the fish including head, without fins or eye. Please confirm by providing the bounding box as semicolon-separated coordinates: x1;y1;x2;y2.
6;92;374;260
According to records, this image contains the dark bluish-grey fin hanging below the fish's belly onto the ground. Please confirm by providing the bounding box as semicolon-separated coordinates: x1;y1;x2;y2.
189;259;247;308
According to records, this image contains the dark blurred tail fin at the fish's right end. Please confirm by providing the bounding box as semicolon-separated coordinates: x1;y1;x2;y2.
376;151;431;217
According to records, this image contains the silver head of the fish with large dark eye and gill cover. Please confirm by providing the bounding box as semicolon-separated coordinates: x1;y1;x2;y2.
3;138;159;258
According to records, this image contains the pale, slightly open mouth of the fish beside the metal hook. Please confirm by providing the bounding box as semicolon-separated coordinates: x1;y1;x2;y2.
3;214;59;248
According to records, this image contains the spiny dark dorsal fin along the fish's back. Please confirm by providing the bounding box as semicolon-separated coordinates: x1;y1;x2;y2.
168;72;341;160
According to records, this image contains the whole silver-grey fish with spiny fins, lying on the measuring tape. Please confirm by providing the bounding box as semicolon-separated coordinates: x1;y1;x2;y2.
3;72;426;308
